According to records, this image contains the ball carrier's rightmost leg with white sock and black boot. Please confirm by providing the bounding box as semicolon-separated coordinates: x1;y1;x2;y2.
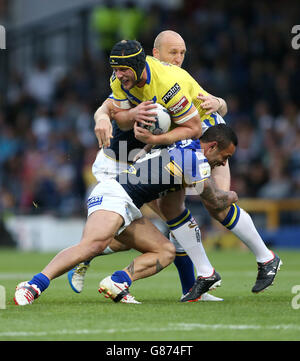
203;162;281;292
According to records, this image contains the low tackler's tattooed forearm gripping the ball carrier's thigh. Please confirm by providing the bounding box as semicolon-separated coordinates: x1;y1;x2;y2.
195;177;238;211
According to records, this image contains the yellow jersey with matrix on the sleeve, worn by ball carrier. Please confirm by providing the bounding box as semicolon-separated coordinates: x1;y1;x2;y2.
110;56;208;123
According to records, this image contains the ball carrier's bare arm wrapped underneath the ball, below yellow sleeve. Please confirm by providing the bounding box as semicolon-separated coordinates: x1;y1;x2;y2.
134;105;202;145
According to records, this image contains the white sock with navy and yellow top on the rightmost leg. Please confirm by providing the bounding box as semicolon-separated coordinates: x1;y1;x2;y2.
221;204;273;263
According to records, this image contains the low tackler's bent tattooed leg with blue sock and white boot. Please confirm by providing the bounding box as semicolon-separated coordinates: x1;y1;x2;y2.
99;217;175;303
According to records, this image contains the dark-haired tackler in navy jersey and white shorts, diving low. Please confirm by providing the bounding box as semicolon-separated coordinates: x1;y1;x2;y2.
14;124;238;306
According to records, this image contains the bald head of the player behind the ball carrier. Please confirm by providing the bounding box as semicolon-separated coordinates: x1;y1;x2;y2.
153;30;186;67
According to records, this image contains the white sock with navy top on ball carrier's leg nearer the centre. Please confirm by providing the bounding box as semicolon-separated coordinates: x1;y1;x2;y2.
167;209;214;277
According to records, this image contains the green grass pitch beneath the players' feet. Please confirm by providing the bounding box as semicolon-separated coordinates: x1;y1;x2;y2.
0;249;300;341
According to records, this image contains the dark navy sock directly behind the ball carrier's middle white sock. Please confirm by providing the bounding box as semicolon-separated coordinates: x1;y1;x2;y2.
174;253;195;295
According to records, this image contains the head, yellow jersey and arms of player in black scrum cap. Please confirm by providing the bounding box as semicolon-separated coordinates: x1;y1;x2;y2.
110;44;205;145
